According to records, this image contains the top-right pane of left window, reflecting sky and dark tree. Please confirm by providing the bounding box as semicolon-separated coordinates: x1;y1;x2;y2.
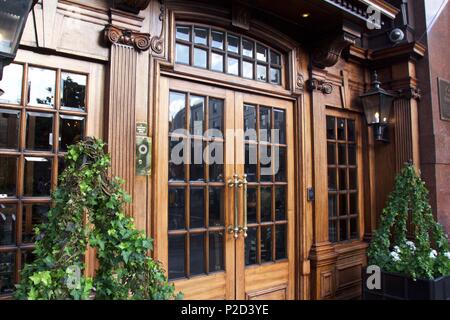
61;72;87;110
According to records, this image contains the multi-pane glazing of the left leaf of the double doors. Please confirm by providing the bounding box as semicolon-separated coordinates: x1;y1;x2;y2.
168;91;225;279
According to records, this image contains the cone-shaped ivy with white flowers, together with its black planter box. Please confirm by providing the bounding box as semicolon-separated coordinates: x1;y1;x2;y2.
363;163;450;300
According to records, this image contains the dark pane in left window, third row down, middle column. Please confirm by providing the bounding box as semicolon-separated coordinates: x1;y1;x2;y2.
24;157;52;197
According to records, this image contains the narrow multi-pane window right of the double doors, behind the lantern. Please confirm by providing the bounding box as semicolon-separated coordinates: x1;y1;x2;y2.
326;116;359;242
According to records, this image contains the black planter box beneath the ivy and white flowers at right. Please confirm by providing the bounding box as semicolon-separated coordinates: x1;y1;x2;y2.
362;269;450;300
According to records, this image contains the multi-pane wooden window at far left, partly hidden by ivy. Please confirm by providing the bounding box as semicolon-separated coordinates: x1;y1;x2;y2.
0;64;88;296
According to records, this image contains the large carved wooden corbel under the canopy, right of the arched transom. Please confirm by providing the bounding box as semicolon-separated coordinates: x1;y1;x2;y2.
312;32;356;69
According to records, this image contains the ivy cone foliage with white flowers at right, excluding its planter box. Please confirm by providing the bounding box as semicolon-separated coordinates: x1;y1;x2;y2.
368;163;450;279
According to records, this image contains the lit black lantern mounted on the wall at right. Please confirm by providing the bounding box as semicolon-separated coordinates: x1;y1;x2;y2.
360;72;395;142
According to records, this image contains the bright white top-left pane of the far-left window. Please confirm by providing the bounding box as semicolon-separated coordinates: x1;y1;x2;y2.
0;63;23;104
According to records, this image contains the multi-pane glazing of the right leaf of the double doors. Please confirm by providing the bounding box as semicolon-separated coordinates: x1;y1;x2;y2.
243;104;288;266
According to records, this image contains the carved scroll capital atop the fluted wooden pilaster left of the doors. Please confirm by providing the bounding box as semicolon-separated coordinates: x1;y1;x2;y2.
105;25;152;51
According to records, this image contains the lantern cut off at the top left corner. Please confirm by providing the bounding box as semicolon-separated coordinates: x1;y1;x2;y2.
0;0;37;80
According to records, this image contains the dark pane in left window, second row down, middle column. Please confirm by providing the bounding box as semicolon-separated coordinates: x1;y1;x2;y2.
26;112;53;151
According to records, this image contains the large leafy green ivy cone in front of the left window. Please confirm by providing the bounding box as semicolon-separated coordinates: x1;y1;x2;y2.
16;138;181;300
